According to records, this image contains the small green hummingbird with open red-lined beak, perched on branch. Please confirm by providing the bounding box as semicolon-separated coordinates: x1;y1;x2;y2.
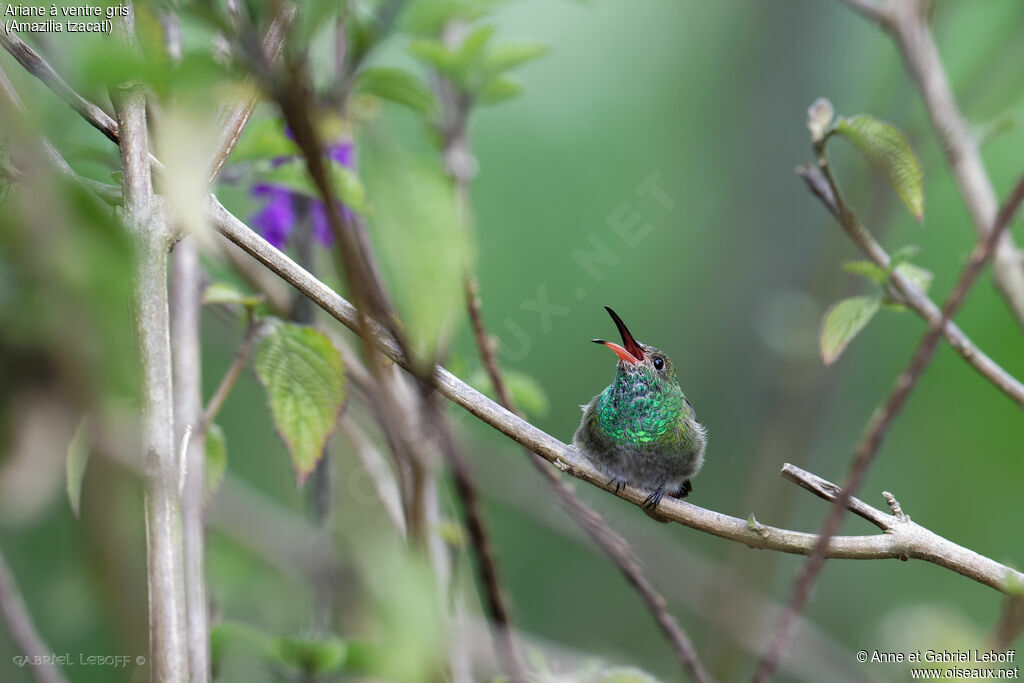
572;306;708;514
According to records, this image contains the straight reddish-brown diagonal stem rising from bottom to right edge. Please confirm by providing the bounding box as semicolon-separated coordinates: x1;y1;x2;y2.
754;169;1024;683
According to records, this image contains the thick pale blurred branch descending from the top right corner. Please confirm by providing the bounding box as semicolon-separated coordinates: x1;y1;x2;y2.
844;0;1024;327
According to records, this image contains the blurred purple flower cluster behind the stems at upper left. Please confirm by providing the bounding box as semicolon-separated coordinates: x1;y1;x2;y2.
252;128;355;249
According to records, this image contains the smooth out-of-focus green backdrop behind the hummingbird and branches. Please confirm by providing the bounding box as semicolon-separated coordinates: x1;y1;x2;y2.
0;0;1024;681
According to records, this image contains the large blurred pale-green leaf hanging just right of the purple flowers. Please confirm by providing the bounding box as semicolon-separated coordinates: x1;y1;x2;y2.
359;129;474;361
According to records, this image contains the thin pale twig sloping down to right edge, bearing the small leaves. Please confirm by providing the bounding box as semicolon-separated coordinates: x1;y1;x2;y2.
797;162;1024;408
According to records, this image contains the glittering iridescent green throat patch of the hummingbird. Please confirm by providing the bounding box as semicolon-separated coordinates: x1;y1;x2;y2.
597;364;689;449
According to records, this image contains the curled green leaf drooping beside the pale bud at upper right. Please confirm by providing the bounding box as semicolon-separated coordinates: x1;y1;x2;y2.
835;114;925;221
